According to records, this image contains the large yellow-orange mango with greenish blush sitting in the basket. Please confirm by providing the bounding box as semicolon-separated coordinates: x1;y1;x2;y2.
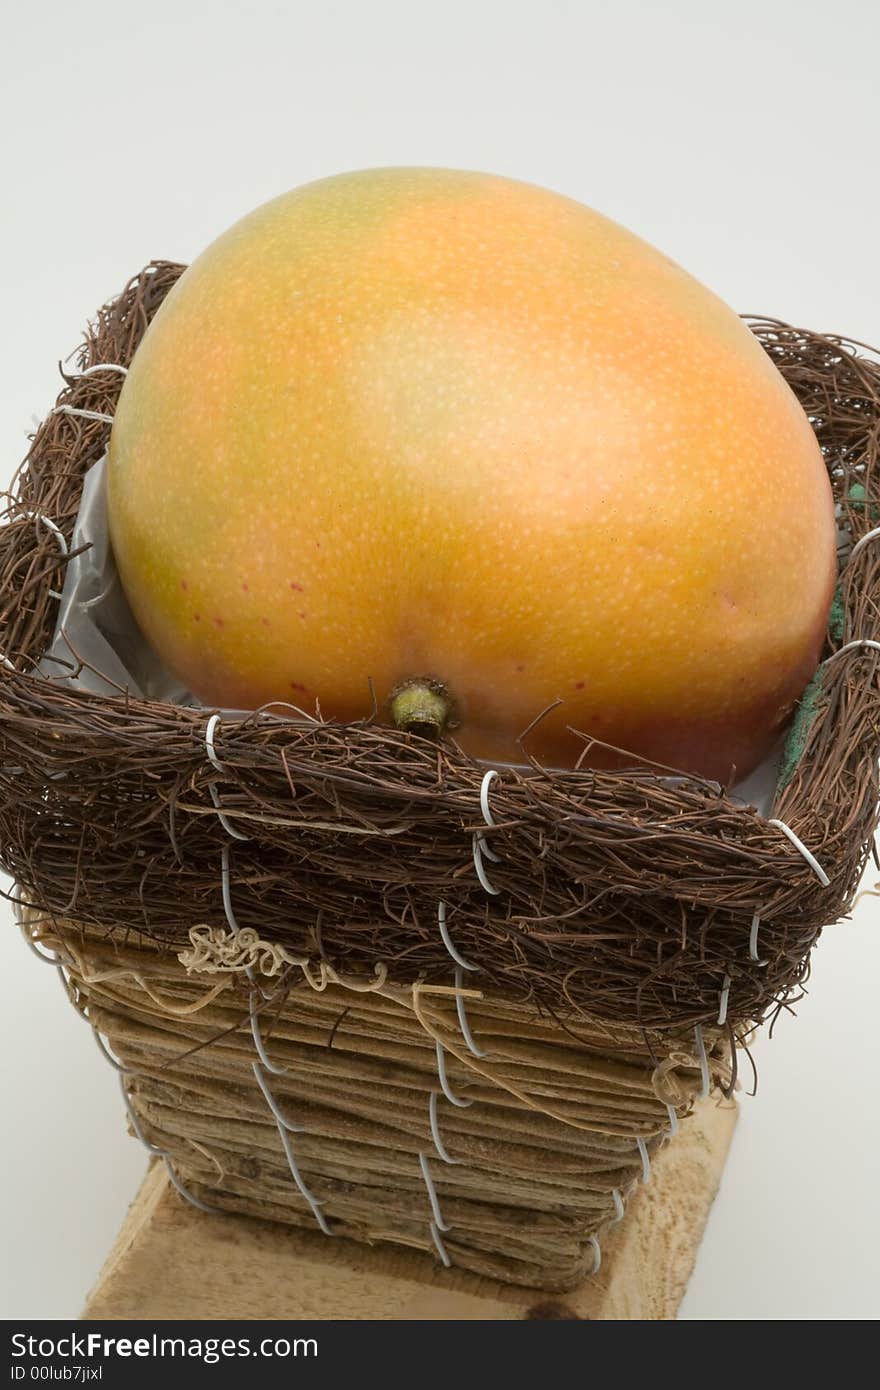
108;168;836;778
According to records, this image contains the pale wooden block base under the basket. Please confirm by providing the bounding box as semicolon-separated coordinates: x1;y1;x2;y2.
83;1098;737;1321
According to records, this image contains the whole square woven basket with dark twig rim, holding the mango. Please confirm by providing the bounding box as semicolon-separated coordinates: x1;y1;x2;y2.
0;263;880;1290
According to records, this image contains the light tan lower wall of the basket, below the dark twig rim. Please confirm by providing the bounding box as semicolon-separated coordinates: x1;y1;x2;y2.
28;915;733;1290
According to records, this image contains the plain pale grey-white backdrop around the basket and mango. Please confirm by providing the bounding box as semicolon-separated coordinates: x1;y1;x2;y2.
0;0;880;1319
